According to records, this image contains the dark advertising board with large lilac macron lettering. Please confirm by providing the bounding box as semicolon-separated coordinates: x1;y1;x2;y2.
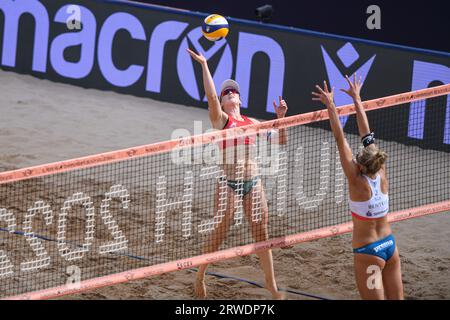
0;0;450;151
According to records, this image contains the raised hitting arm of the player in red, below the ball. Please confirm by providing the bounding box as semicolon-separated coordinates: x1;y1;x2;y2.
187;49;228;129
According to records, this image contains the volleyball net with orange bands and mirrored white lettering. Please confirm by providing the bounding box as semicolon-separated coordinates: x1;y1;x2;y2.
0;84;450;299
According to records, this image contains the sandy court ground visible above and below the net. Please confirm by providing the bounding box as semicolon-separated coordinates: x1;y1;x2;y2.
0;71;450;299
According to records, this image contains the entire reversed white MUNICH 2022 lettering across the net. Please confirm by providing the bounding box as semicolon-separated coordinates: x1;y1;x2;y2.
0;141;384;277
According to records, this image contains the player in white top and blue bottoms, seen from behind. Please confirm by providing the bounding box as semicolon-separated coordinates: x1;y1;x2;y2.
312;75;403;300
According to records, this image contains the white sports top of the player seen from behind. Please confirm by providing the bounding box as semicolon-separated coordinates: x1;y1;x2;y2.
348;174;389;219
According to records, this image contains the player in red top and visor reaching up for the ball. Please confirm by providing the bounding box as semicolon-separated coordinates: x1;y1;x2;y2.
188;49;287;299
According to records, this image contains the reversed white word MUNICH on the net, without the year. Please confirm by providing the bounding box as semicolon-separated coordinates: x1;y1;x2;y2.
155;139;345;243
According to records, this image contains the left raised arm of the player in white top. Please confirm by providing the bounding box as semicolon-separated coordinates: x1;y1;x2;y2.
312;81;359;180
